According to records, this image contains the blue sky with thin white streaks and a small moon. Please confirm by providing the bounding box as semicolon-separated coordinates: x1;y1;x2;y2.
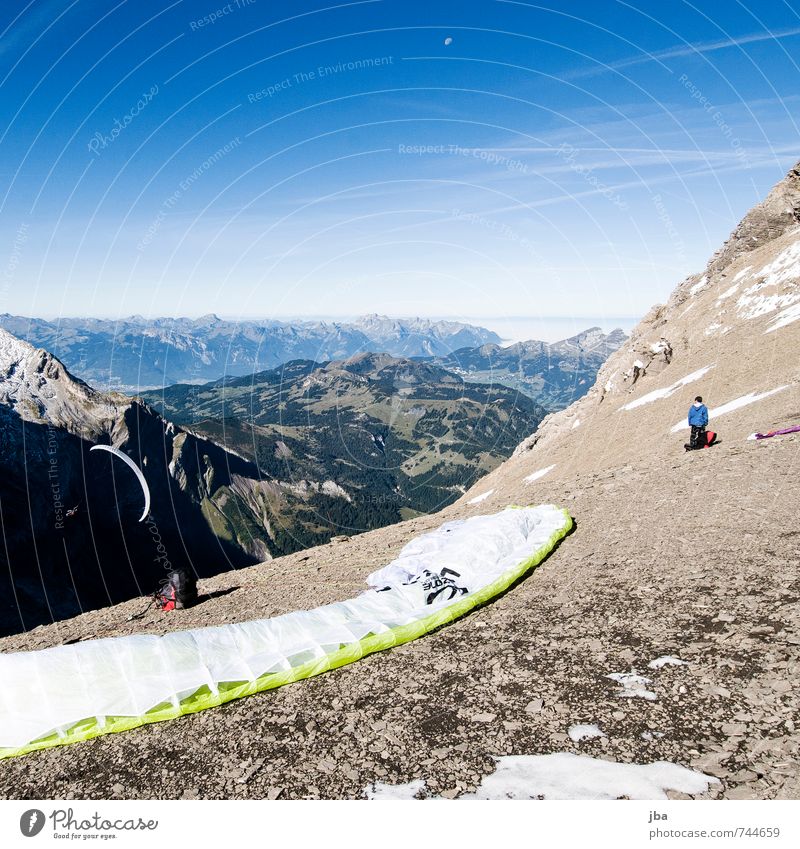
0;0;800;326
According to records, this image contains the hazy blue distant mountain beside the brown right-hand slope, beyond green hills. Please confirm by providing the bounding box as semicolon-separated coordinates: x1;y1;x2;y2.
428;327;628;412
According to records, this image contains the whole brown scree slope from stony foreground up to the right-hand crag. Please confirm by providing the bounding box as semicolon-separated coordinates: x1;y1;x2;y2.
0;161;800;799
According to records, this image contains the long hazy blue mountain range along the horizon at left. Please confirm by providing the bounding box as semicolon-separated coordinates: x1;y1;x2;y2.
0;313;500;392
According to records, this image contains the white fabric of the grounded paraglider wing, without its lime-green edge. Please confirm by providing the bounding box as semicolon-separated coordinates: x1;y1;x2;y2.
0;505;568;748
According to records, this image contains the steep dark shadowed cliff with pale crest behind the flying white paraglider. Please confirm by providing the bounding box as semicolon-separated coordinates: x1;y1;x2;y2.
0;330;282;633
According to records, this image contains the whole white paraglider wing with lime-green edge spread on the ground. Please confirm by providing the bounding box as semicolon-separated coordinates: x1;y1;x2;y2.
0;505;572;757
